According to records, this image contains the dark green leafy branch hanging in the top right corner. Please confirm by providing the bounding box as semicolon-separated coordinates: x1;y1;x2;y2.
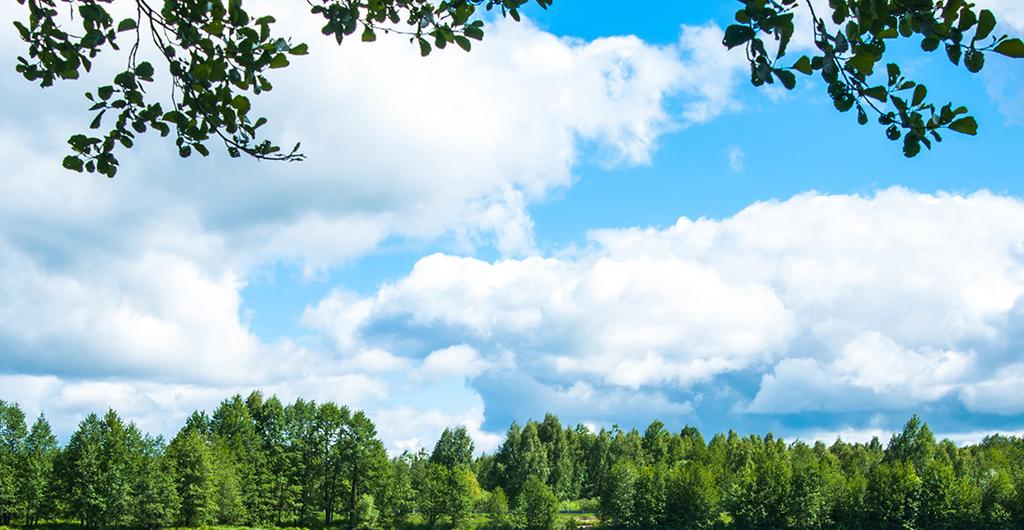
723;0;1024;158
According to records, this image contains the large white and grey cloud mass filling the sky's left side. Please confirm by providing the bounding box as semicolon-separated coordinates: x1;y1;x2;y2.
0;6;757;447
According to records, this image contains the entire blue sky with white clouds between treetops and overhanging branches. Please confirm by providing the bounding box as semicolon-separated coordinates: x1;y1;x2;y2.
0;0;1024;450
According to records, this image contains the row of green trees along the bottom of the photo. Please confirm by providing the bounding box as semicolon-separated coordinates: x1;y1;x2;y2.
0;392;1024;530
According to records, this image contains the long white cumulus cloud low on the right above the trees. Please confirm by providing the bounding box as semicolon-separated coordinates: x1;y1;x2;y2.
309;188;1024;427
